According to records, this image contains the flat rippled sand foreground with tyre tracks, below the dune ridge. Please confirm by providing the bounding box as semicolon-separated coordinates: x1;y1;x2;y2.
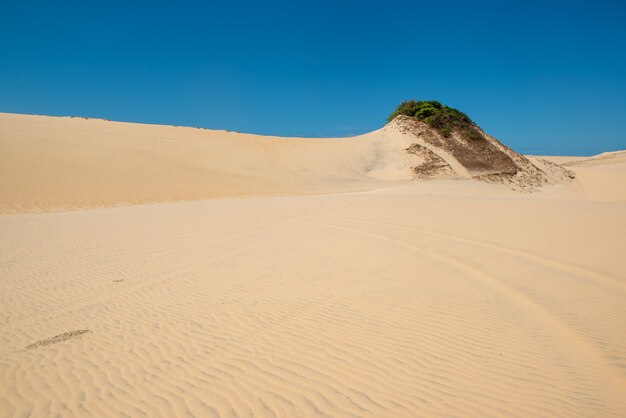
0;189;626;417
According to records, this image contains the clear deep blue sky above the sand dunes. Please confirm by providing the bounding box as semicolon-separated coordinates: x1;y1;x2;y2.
0;0;626;155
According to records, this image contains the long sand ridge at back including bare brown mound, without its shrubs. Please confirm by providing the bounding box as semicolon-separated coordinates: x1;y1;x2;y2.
0;114;572;213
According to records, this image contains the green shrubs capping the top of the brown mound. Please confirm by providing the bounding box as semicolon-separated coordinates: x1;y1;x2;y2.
387;100;482;140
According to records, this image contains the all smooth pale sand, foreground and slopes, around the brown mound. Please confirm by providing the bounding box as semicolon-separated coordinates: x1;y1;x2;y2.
0;114;626;417
